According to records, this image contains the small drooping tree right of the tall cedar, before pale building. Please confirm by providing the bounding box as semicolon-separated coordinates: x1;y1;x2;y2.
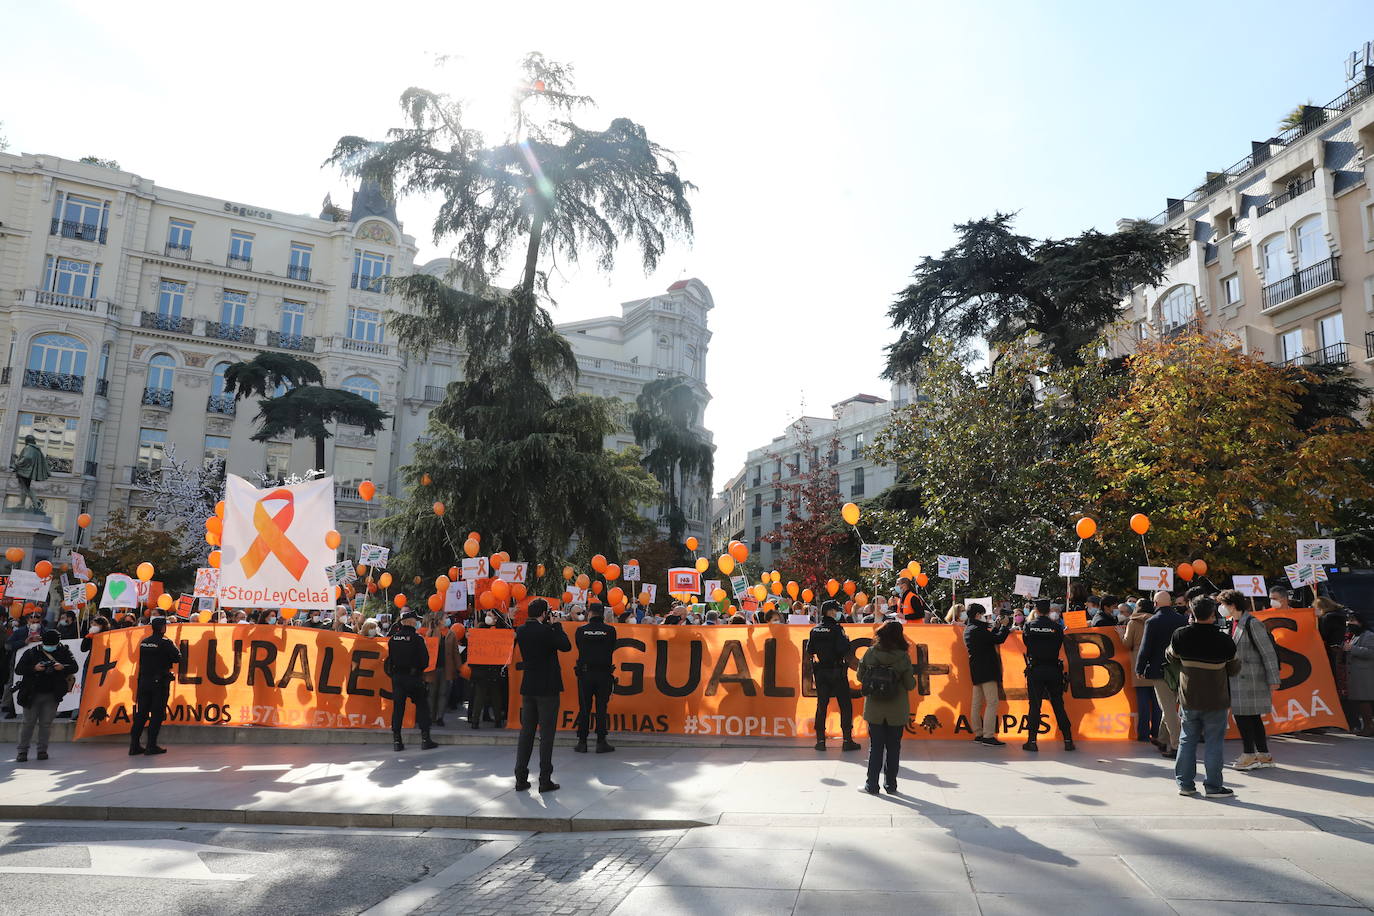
629;375;716;544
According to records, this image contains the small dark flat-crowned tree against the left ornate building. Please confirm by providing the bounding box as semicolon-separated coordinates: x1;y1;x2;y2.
224;353;390;470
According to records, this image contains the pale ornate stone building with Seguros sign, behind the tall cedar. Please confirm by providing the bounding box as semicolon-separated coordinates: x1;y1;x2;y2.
0;152;712;555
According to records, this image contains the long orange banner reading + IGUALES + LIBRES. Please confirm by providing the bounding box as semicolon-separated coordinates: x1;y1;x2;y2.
510;611;1345;740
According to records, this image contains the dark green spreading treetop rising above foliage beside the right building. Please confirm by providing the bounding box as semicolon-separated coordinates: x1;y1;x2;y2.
885;213;1183;378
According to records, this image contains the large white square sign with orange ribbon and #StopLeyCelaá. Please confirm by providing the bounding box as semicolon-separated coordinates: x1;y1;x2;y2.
220;474;337;610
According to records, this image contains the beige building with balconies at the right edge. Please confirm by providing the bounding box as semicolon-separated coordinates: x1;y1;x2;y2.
1113;67;1374;382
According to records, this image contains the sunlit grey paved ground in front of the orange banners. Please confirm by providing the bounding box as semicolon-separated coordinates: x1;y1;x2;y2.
0;735;1374;916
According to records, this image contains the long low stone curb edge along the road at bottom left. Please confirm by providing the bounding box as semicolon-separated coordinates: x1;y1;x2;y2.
0;805;712;834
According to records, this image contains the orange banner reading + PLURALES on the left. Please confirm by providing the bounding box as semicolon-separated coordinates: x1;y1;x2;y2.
76;623;438;739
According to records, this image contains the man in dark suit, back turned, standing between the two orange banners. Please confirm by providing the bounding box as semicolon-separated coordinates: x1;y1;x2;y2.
515;597;573;792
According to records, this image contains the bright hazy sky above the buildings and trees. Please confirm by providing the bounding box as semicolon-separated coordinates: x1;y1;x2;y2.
0;0;1374;485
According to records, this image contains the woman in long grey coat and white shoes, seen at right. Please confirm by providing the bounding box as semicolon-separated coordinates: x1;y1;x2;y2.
1216;588;1279;770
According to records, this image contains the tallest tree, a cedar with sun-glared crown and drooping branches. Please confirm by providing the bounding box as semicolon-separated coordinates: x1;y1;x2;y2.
330;54;691;569
